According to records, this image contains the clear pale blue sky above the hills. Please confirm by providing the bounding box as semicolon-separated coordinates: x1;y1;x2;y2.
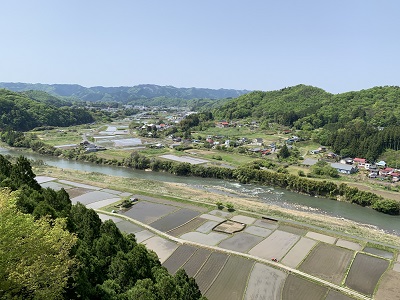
0;0;400;93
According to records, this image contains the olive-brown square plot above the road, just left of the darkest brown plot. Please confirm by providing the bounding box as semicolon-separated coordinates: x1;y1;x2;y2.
299;243;354;284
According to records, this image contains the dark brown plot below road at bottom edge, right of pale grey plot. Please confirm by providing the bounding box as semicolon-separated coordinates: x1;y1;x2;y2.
282;275;328;300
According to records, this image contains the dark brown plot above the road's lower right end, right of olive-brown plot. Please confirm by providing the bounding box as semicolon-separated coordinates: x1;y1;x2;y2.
346;253;389;295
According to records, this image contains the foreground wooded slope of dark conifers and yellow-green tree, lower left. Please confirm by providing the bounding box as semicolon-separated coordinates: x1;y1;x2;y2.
0;155;206;300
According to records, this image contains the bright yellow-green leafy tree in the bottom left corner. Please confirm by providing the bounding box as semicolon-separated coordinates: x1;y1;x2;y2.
0;190;77;299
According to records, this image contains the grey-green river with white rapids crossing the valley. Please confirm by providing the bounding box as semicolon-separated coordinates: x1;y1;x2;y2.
0;148;400;236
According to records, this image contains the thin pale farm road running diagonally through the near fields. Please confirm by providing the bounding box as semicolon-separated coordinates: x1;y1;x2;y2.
95;210;372;300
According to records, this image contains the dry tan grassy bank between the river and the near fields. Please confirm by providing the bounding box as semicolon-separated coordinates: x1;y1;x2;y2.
34;165;400;246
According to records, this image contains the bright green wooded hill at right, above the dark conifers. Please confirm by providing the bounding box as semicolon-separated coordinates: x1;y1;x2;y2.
213;85;400;129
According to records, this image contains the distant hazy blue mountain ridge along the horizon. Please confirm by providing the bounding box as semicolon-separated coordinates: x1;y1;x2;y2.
0;82;249;104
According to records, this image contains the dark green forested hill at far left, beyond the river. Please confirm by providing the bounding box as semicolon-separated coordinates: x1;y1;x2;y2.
0;89;94;131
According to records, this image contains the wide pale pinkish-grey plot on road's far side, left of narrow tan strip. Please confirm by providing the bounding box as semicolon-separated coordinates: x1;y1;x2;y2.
249;230;300;260
